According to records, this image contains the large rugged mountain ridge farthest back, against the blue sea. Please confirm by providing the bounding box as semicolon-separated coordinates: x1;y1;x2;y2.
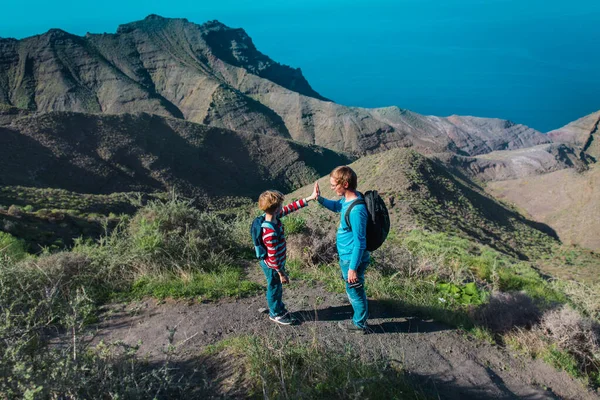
0;15;549;155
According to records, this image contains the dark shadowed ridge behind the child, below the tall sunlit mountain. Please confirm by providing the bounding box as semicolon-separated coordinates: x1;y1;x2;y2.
0;112;350;204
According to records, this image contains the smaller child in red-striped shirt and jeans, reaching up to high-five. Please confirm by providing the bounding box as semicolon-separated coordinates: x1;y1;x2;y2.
258;183;318;325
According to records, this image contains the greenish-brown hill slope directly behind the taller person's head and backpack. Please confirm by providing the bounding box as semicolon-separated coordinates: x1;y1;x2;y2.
291;149;556;258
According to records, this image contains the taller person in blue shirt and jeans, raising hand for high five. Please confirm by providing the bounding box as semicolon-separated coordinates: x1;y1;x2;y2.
315;166;370;333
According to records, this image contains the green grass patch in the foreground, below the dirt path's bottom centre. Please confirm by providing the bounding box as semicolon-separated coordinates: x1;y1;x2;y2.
208;337;425;399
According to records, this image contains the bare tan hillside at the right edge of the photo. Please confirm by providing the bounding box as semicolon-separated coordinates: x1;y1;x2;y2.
482;111;600;250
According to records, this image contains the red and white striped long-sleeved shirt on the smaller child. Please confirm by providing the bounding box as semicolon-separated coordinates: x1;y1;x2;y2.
262;199;308;271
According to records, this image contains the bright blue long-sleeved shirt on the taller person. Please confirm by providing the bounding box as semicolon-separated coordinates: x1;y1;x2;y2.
318;193;371;270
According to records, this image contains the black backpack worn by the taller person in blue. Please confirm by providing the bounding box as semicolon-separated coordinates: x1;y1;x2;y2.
345;190;390;251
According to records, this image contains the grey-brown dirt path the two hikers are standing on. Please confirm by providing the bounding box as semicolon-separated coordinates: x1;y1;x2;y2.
97;283;598;399
